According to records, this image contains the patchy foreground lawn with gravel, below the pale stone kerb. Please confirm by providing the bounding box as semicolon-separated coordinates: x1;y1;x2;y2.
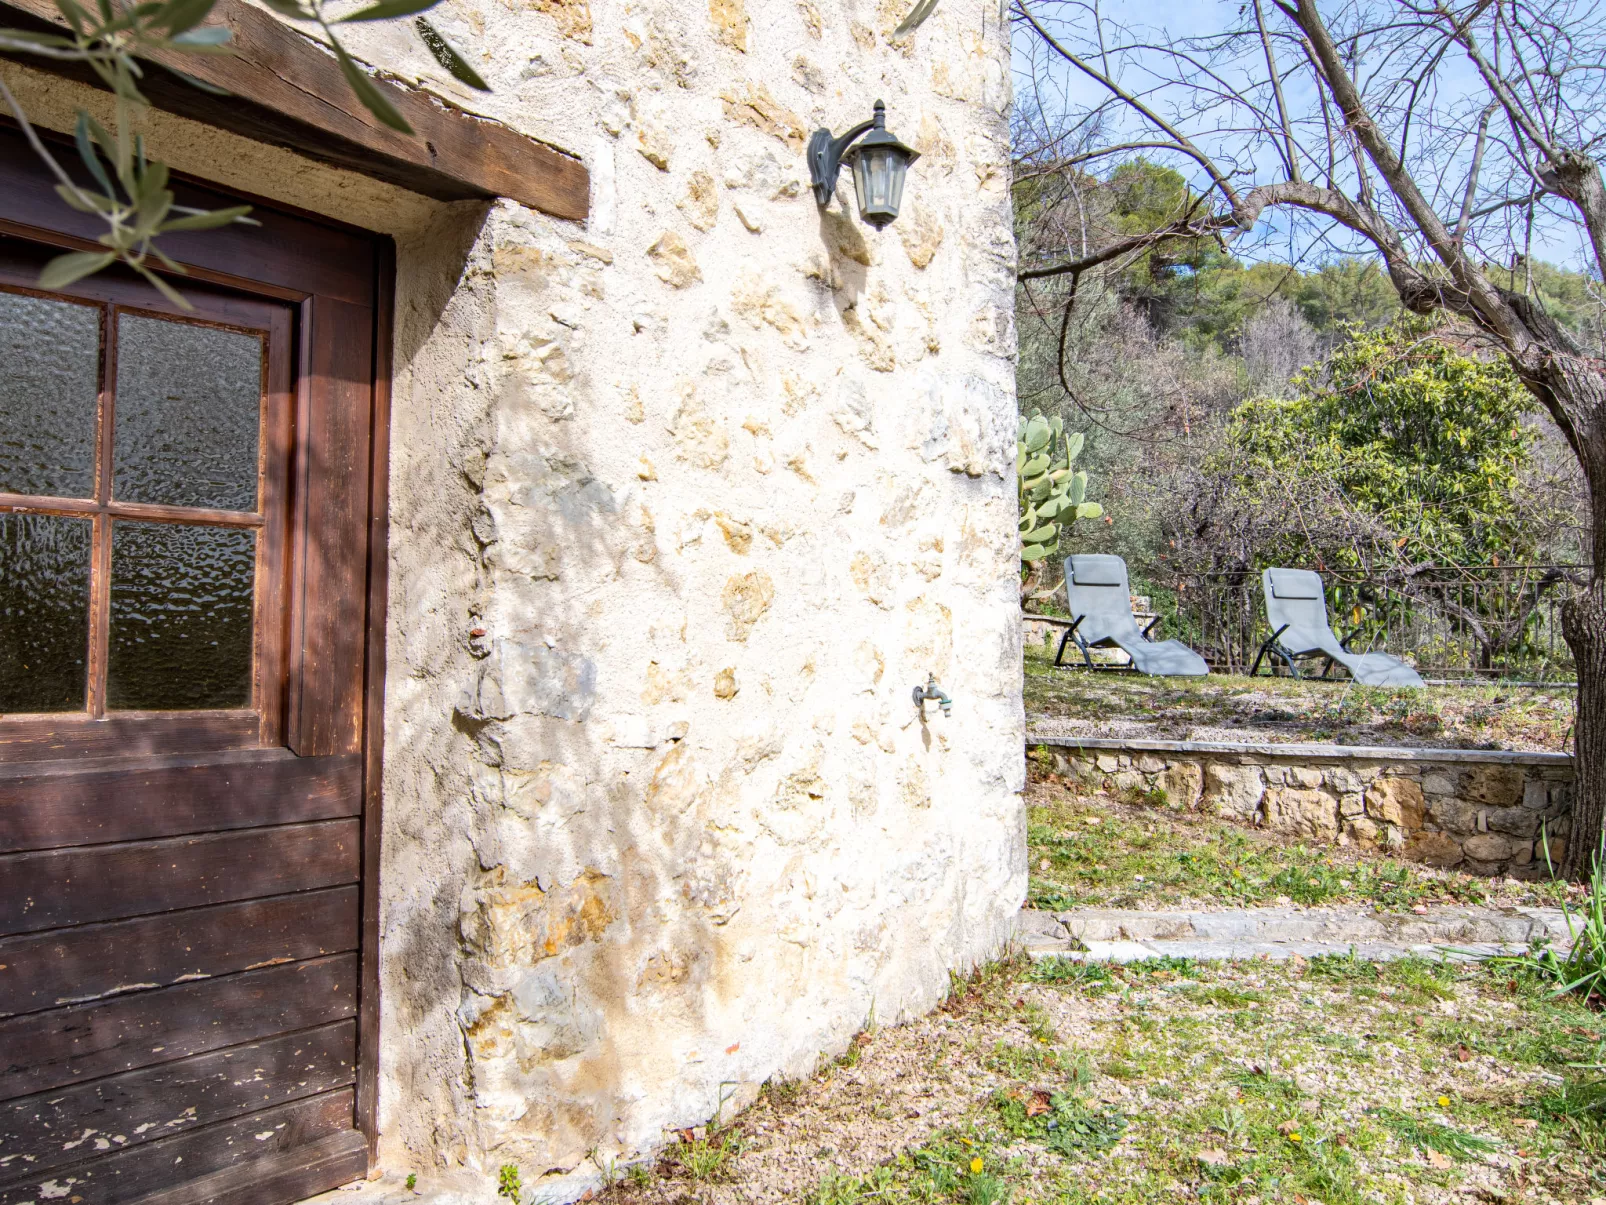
604;958;1606;1205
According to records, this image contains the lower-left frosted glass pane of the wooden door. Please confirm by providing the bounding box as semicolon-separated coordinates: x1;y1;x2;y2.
0;514;90;712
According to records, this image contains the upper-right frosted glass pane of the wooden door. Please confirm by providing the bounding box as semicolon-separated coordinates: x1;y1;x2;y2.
112;315;262;511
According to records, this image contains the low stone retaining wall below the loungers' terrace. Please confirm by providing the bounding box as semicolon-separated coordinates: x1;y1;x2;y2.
1036;741;1572;879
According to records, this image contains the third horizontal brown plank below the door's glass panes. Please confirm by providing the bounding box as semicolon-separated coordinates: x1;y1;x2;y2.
0;885;358;1017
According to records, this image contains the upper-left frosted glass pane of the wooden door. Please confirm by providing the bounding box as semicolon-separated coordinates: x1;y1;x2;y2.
0;292;100;498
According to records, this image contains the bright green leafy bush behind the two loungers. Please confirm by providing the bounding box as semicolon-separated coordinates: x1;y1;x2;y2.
1232;318;1534;564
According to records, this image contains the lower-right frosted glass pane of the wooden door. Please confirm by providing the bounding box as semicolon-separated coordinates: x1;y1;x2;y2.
106;522;257;712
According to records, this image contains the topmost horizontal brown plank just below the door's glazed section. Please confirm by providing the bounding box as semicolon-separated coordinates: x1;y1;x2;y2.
0;750;363;853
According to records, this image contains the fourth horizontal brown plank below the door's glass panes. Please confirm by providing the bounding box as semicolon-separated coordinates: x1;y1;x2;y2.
0;954;357;1101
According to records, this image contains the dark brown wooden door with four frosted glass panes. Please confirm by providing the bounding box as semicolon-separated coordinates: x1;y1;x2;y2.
0;125;384;1205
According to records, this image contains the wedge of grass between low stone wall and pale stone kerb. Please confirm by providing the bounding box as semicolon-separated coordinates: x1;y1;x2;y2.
1026;773;1567;911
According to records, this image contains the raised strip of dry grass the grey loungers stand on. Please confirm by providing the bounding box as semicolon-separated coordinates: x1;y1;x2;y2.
1025;646;1574;752
